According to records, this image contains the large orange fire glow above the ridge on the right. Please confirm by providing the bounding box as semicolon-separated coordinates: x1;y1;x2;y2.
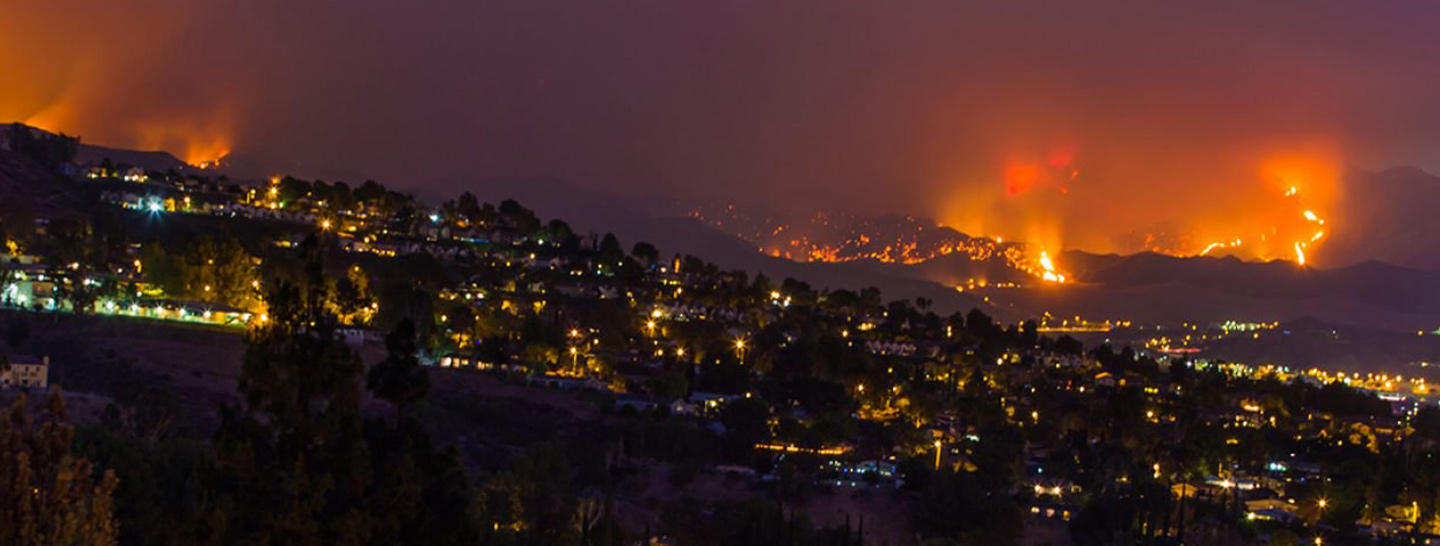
940;141;1341;269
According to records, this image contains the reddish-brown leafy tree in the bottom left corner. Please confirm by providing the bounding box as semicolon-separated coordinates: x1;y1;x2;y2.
0;390;118;546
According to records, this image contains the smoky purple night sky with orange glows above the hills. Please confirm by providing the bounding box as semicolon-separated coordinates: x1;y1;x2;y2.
0;0;1440;246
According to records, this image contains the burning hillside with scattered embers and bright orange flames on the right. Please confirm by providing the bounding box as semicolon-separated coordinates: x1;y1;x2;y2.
688;147;1341;282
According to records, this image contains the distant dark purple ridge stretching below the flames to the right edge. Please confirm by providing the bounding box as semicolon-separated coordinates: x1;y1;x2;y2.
434;172;1440;333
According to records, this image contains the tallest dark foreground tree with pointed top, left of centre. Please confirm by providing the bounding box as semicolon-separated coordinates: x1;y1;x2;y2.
215;279;373;546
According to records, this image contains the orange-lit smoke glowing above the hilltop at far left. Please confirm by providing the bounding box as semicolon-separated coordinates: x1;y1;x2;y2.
0;1;252;164
